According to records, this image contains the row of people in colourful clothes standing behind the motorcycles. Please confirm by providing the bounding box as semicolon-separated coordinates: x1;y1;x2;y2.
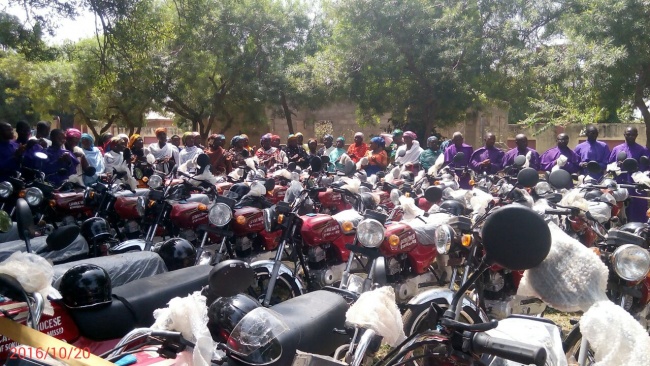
0;121;649;221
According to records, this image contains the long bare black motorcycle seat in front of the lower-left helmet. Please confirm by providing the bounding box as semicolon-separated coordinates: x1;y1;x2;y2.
70;265;212;341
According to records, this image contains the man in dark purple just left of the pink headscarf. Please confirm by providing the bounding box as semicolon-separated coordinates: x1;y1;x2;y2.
24;129;79;186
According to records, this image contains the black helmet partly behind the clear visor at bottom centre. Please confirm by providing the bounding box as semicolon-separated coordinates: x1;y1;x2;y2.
208;294;260;342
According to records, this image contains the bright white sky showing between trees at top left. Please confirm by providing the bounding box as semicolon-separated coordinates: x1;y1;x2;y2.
0;0;95;45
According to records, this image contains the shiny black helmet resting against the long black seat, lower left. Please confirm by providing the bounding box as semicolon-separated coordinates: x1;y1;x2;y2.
59;264;111;308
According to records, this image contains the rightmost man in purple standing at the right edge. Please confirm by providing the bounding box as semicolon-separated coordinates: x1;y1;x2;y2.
609;127;649;222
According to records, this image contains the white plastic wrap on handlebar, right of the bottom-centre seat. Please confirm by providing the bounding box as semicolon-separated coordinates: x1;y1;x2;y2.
345;286;406;347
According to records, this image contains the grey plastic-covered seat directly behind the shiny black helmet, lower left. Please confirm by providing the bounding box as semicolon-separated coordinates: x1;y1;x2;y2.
52;252;167;289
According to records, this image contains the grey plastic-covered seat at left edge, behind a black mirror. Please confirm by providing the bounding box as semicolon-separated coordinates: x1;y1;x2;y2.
0;235;89;263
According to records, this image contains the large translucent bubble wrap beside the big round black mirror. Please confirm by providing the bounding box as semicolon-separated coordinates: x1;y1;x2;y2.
517;224;609;312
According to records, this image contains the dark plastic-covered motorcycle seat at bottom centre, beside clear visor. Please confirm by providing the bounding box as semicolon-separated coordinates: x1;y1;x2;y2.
271;290;350;365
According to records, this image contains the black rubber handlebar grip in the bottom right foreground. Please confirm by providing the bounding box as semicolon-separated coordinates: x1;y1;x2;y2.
471;333;546;366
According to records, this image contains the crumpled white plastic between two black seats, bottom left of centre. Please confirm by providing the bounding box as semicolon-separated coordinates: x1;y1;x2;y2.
151;291;215;366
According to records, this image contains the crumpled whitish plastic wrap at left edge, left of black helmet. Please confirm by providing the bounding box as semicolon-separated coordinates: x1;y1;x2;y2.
0;252;61;315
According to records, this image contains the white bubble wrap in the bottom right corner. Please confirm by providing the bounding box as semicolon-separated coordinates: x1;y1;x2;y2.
580;301;650;366
